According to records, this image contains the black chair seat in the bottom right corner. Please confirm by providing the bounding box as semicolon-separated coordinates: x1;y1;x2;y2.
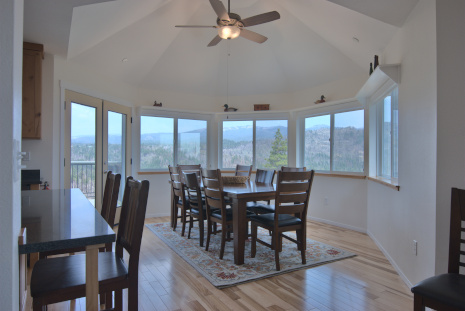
412;273;465;310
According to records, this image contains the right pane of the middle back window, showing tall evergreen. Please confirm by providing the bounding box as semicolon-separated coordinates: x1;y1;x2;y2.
255;120;287;169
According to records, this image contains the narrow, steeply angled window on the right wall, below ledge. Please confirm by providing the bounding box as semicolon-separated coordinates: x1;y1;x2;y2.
376;88;399;179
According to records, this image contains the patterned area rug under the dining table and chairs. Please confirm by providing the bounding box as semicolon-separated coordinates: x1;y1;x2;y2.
146;223;356;288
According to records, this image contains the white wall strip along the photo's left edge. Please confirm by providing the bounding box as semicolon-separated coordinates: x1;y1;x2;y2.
0;0;23;311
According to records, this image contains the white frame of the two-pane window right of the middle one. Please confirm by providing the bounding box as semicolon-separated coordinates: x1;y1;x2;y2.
295;100;368;176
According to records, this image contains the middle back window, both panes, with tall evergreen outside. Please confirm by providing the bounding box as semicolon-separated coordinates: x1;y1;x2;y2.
221;120;288;169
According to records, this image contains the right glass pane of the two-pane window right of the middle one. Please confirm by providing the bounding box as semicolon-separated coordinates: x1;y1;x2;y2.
333;110;364;172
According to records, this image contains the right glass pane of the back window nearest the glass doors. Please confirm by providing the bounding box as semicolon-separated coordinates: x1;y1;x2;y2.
177;119;207;167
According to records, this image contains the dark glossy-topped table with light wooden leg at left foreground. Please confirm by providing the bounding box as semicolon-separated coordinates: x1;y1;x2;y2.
19;188;116;311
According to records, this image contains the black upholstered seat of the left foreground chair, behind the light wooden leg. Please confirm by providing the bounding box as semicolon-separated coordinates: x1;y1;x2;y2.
31;252;128;299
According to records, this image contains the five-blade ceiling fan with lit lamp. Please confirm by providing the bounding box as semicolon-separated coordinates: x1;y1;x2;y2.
175;0;281;46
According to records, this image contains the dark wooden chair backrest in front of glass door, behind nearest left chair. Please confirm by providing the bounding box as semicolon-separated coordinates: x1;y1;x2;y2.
100;171;121;228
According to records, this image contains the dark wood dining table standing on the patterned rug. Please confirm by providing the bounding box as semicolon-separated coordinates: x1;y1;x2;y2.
223;181;276;265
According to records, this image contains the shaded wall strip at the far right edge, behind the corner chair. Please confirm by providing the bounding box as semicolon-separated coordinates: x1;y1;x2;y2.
436;0;465;273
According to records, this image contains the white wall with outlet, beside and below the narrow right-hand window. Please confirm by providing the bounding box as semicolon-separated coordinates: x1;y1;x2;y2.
367;0;437;284
